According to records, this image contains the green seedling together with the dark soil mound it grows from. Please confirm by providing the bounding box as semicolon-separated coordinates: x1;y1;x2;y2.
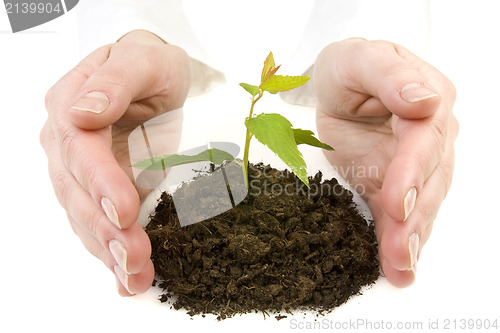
140;54;380;320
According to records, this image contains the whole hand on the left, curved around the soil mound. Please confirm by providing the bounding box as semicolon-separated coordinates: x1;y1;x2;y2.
40;31;191;296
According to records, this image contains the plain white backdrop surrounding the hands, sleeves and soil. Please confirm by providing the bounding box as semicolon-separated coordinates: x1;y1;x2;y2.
0;0;500;332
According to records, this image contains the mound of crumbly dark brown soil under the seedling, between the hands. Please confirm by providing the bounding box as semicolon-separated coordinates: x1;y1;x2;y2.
146;164;379;319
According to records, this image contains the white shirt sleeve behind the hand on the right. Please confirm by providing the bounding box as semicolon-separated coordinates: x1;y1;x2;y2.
280;0;430;106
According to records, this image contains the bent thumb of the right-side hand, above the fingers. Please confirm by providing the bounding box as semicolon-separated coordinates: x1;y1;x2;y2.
313;39;440;119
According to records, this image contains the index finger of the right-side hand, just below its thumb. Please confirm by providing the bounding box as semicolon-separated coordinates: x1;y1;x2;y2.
381;112;458;221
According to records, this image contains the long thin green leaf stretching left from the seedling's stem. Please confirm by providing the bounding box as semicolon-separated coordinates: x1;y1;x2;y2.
132;148;234;171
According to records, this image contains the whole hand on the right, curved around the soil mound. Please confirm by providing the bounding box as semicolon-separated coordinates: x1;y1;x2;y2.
313;39;458;287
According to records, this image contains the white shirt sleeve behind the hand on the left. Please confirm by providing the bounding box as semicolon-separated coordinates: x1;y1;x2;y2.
77;0;225;96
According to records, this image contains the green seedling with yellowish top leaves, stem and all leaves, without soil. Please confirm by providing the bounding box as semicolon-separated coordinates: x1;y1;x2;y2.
132;52;333;186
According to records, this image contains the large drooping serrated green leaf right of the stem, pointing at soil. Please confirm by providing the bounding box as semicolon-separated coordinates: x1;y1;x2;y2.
245;113;309;186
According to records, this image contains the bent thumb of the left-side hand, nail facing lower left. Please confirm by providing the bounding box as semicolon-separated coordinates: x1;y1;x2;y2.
69;43;190;129
